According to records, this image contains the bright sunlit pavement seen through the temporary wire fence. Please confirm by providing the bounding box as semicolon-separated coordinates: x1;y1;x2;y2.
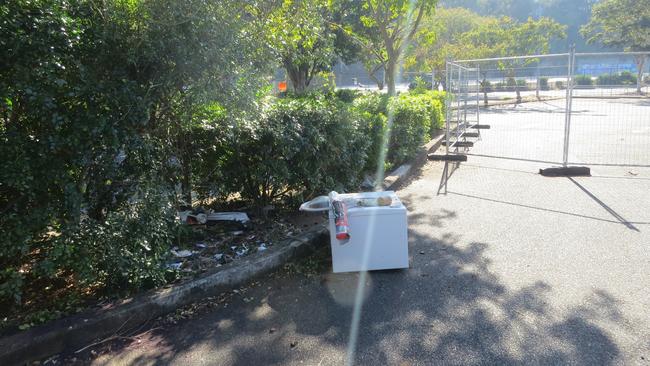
464;99;650;165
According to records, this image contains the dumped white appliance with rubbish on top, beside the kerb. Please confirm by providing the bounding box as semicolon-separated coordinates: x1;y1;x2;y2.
300;191;409;273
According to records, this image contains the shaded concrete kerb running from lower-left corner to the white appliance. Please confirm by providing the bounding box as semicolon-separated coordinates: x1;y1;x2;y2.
0;226;328;365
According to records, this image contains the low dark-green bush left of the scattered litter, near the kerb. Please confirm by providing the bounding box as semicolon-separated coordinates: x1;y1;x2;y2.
52;189;177;296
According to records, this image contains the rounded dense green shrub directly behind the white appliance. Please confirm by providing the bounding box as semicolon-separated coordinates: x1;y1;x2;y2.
226;96;371;207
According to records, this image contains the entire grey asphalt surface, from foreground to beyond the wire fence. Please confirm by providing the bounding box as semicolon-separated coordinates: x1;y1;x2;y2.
62;96;650;365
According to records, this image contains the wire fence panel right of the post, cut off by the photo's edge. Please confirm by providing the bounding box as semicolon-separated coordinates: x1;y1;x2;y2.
568;53;650;166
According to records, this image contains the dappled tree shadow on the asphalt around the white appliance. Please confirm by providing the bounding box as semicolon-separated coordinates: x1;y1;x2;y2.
68;207;636;365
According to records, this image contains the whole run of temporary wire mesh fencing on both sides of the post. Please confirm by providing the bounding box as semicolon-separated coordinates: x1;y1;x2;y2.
446;50;650;166
